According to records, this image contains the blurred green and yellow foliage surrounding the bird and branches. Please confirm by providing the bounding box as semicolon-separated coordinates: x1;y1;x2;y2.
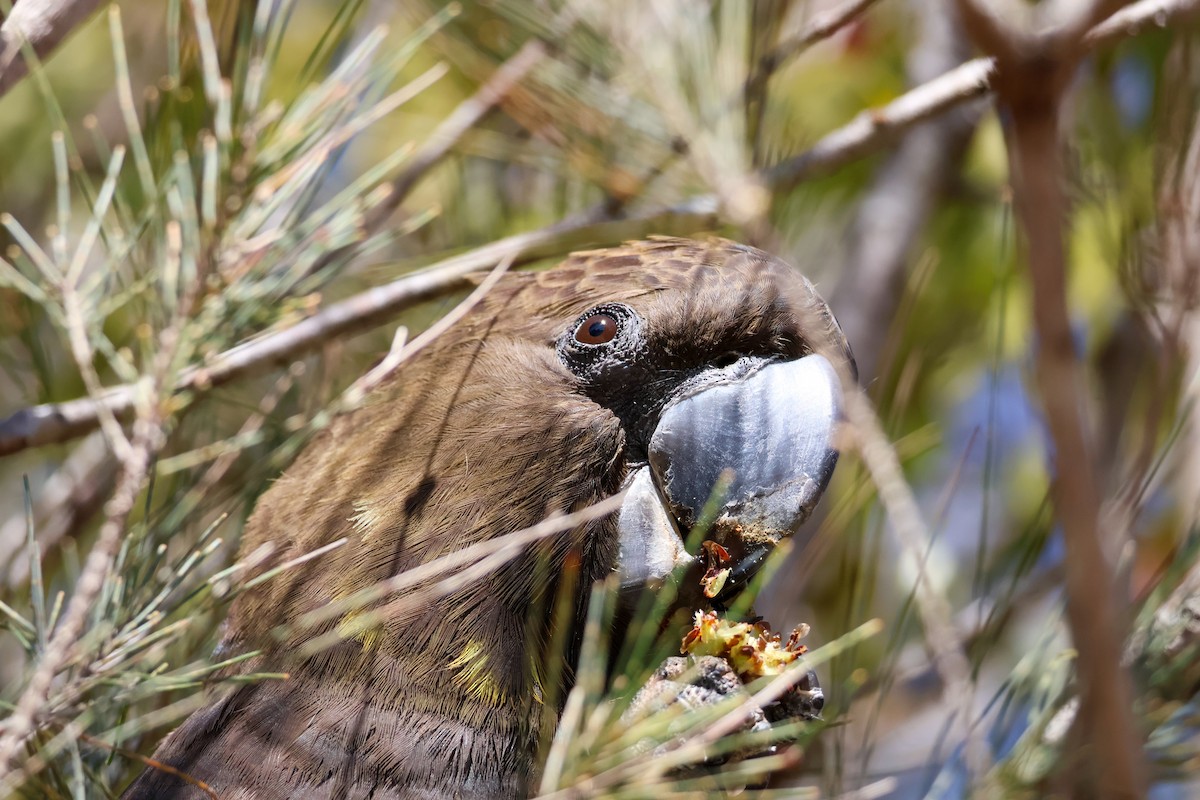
0;0;1200;796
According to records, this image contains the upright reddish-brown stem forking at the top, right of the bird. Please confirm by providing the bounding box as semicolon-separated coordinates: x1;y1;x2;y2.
958;0;1146;798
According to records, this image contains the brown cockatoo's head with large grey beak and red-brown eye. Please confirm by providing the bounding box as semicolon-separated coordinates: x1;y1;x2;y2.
220;237;853;669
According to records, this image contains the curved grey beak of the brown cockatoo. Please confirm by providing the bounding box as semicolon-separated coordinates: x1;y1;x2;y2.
618;354;842;597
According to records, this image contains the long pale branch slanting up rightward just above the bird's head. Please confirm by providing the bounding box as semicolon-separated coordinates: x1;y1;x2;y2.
0;0;1200;456
